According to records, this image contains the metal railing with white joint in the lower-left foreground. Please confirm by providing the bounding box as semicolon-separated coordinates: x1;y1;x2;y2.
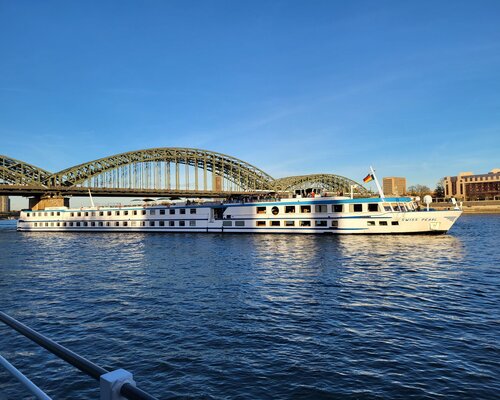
0;311;156;400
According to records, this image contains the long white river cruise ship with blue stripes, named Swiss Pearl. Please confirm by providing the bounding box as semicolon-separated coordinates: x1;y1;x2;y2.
17;196;462;234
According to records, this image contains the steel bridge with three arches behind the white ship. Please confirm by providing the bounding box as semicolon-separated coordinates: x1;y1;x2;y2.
0;147;366;196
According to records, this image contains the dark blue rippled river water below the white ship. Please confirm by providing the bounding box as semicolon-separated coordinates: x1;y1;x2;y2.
0;215;500;399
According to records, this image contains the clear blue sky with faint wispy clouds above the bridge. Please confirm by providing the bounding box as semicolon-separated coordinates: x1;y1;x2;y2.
0;0;500;198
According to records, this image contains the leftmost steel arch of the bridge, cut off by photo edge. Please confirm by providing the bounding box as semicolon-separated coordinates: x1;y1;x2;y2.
0;155;51;185
